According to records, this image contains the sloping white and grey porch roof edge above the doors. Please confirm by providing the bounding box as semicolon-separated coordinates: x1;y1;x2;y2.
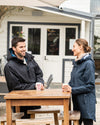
27;6;94;22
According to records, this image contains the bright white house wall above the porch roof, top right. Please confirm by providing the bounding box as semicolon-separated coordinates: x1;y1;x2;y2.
61;0;90;12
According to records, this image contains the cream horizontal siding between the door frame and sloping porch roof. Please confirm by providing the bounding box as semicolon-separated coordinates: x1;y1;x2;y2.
9;8;80;23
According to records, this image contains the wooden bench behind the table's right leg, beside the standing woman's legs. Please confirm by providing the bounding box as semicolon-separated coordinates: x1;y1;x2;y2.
58;111;80;125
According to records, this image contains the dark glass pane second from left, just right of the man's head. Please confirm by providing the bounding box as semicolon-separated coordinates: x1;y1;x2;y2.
28;28;41;54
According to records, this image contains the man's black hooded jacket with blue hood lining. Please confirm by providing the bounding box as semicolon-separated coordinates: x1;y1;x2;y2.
4;49;44;91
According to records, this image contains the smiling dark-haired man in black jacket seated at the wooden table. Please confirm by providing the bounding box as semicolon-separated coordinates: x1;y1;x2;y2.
4;37;44;118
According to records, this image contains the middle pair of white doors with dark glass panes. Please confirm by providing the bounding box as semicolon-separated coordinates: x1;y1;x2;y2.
27;25;63;82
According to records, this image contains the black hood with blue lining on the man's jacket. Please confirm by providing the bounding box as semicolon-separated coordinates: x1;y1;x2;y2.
7;48;34;63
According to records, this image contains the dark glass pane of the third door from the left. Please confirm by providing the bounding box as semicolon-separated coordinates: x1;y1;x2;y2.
47;29;59;55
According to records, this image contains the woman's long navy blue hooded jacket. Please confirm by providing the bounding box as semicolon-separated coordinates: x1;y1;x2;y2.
69;54;96;120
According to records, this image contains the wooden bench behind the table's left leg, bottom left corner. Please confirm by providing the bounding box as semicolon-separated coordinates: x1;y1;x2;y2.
0;112;24;125
